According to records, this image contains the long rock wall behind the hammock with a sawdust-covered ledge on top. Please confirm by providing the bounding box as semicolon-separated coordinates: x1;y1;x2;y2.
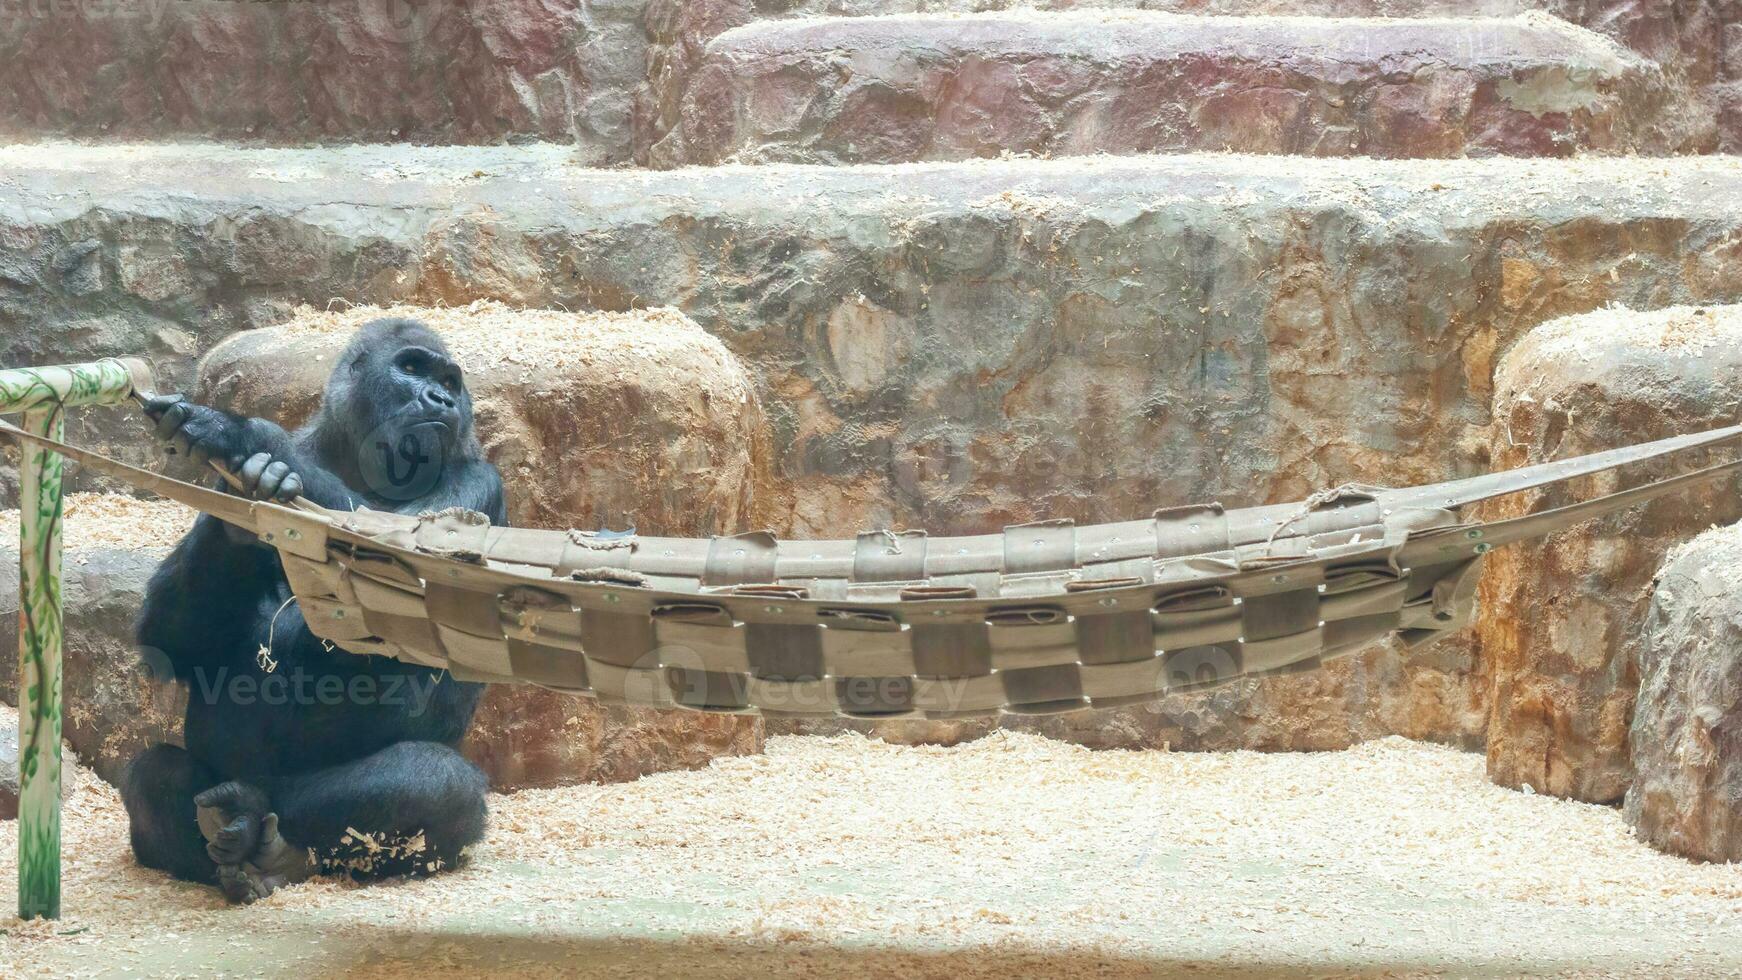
16;146;1742;748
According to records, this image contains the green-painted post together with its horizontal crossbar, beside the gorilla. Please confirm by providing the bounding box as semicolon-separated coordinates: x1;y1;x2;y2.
0;360;152;919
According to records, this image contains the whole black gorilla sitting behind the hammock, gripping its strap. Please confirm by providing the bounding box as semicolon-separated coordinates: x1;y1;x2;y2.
122;320;507;902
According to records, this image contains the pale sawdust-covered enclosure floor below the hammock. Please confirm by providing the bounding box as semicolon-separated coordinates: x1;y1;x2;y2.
0;733;1742;978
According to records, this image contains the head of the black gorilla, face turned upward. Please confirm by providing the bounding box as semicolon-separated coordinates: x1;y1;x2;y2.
327;320;472;501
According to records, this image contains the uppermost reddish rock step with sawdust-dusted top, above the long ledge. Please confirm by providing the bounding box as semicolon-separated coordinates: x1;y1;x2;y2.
674;10;1688;164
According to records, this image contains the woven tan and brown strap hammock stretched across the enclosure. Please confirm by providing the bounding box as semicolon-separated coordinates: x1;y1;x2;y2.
0;416;1742;719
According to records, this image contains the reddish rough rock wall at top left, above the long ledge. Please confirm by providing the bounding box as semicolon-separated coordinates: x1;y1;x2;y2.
0;0;645;164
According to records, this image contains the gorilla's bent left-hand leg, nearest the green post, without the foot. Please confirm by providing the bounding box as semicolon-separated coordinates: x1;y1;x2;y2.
120;745;218;884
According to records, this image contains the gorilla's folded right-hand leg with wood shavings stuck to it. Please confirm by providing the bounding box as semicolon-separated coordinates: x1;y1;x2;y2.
272;742;488;877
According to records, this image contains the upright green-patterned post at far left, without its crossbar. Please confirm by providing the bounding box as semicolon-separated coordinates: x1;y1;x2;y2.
17;404;66;919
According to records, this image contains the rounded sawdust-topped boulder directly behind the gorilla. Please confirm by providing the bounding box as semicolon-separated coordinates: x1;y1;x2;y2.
195;303;763;789
